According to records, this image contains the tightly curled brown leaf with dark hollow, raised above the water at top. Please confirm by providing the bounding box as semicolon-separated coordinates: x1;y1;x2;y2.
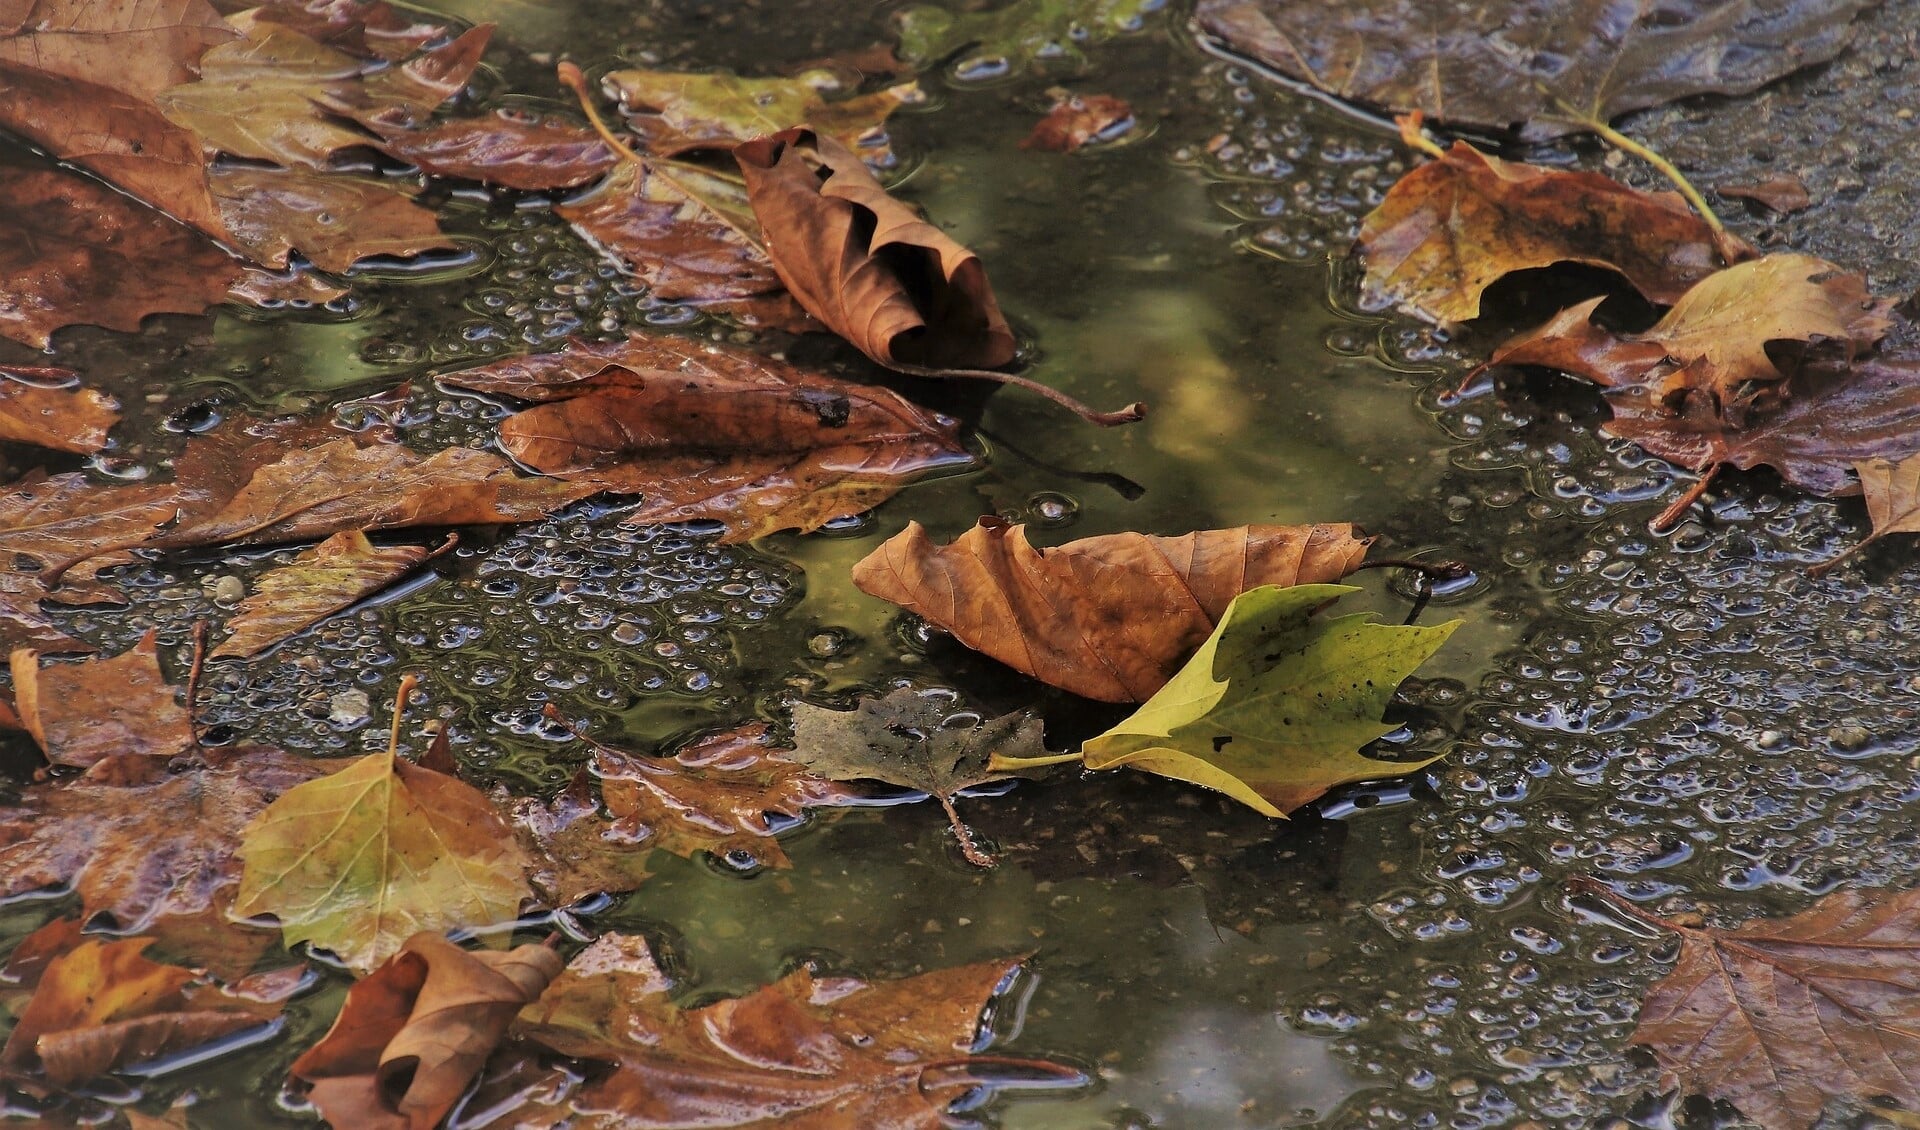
733;129;1016;368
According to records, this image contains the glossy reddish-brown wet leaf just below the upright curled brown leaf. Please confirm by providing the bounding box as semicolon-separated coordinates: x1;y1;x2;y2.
442;334;972;541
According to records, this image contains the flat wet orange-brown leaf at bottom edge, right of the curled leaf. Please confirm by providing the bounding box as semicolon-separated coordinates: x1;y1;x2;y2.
516;934;1081;1130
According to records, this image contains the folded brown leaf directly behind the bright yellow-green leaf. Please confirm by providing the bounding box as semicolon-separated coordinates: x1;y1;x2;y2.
852;522;1371;702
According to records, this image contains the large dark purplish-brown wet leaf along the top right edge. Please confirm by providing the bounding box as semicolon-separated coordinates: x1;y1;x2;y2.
1196;0;1868;140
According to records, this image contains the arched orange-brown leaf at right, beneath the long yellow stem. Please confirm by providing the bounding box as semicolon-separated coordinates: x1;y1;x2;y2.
1359;142;1743;322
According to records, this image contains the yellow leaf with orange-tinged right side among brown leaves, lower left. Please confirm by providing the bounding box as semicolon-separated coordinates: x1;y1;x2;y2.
234;750;532;973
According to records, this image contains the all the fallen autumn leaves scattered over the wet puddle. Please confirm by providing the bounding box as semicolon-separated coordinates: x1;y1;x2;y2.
0;0;1920;1128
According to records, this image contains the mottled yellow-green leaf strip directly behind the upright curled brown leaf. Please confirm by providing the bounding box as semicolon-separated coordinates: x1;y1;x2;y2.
601;69;927;169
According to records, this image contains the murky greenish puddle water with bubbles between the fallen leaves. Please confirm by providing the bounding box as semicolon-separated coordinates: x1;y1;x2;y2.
11;0;1920;1130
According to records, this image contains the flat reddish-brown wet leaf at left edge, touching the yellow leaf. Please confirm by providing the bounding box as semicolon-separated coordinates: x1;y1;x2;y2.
0;748;326;977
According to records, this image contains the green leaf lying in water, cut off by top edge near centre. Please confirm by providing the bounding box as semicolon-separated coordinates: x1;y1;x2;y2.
895;0;1165;81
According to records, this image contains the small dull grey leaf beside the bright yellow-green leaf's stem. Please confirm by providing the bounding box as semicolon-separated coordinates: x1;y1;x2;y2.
793;687;1046;867
